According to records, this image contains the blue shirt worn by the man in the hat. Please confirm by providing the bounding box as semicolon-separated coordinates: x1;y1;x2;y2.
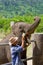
11;45;23;65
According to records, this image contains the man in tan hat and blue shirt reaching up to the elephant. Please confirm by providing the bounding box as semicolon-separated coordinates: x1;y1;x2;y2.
9;33;25;65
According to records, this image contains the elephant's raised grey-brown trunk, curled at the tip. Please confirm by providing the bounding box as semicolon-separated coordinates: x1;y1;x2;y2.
26;16;41;34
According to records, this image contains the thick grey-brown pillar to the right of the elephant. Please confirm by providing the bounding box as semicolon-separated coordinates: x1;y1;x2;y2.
32;33;43;65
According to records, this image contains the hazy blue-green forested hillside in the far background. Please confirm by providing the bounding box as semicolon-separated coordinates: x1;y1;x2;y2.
0;0;43;18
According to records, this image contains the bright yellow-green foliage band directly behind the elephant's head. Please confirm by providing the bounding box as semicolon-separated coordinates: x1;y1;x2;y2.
0;15;43;34
